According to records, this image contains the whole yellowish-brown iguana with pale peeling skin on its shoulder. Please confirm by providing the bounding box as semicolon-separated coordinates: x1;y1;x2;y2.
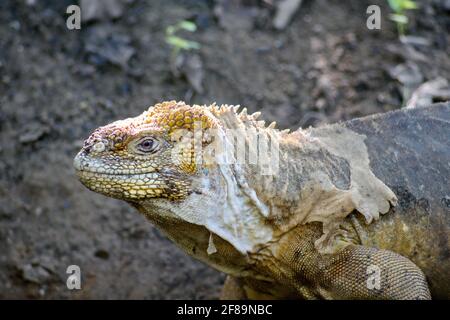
74;101;450;299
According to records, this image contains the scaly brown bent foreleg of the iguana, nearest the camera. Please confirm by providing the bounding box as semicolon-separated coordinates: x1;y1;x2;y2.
316;245;431;300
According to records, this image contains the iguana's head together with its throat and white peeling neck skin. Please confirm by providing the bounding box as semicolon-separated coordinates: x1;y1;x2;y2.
74;101;272;272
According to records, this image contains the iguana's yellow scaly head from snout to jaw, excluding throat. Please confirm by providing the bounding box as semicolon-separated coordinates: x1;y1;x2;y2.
74;101;218;202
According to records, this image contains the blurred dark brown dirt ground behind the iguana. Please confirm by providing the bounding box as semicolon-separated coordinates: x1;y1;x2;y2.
0;0;450;299
